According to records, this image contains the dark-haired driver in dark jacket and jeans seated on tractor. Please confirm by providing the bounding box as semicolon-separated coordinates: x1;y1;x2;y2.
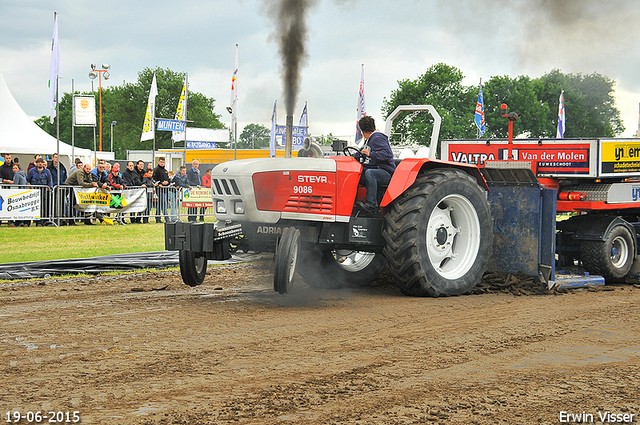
355;115;396;214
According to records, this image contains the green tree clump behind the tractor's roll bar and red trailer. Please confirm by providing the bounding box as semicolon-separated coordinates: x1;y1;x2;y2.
382;63;624;144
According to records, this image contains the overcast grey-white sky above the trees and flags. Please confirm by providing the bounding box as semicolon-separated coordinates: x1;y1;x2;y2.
0;0;640;142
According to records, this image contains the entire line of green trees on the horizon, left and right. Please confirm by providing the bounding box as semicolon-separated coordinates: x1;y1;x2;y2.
36;63;624;159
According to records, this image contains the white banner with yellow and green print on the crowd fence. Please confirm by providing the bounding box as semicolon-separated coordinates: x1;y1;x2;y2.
73;187;147;213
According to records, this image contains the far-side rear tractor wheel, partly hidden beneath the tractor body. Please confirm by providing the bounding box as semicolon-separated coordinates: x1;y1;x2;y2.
298;249;386;289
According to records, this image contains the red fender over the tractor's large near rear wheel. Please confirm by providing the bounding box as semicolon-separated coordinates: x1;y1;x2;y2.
380;158;489;208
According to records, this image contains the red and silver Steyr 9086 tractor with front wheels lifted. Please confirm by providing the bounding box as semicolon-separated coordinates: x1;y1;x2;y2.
165;106;493;296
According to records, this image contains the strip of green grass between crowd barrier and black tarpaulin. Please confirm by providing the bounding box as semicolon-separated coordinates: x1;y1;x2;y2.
0;223;164;263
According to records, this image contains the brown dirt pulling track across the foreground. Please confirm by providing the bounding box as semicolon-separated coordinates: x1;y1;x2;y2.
0;262;640;424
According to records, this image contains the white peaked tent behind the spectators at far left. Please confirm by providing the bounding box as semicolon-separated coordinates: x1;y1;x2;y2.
0;74;93;169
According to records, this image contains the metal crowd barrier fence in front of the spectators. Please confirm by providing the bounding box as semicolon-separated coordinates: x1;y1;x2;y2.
0;185;215;226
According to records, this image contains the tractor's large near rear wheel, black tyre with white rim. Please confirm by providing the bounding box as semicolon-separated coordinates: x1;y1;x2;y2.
383;169;493;297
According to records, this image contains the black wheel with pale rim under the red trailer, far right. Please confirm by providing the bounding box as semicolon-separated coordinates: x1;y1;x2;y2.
580;226;633;280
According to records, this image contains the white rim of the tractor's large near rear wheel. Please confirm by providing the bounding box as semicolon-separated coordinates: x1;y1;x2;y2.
427;194;481;279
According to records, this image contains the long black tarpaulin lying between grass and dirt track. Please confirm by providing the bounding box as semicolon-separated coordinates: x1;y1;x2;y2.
0;251;261;279
